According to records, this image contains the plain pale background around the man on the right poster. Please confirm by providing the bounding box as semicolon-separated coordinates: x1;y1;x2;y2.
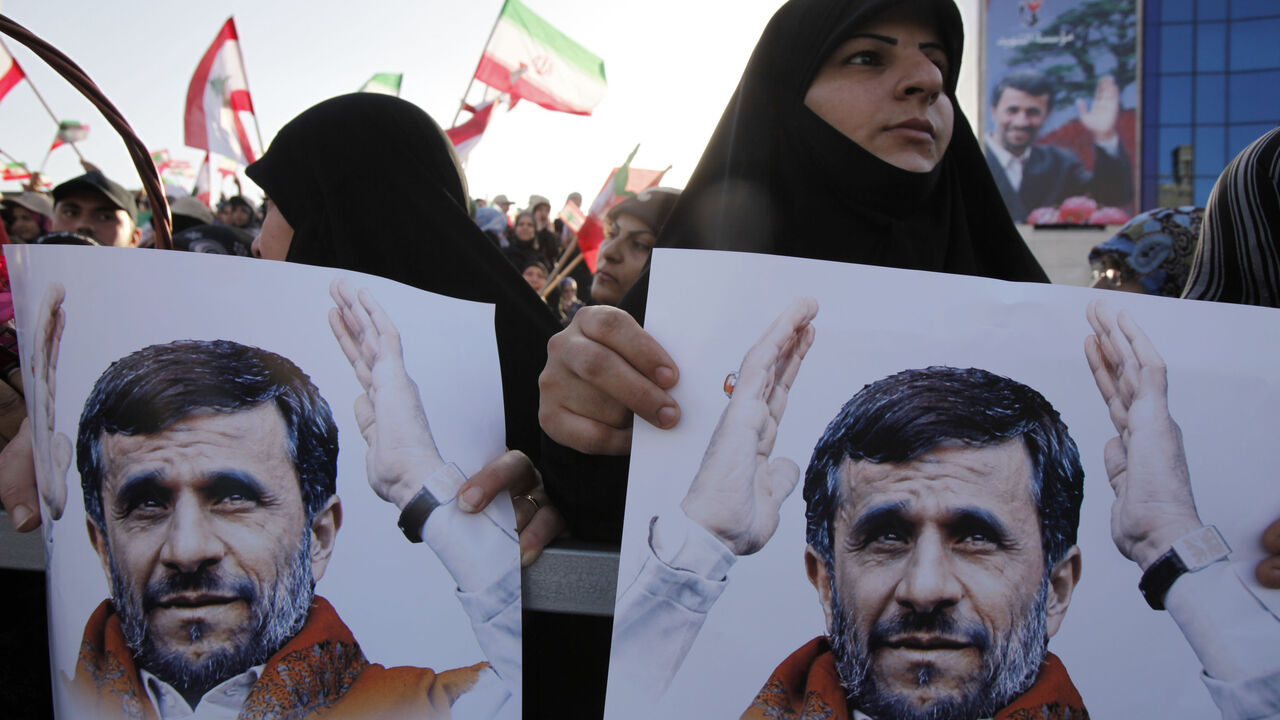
605;250;1280;719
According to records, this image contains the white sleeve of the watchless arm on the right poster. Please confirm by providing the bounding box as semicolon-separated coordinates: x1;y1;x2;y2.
608;512;736;707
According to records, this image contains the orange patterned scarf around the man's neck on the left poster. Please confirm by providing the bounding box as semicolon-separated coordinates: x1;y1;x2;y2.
72;596;488;720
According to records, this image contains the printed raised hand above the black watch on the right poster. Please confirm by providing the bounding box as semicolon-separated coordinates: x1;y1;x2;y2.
1084;300;1202;570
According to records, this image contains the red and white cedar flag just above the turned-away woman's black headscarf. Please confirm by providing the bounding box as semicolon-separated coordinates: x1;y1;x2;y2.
184;18;257;165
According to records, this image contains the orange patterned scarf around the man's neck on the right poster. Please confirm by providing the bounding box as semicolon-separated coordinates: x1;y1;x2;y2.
742;637;1089;720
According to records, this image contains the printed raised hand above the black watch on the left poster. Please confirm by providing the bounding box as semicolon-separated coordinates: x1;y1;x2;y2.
329;281;444;510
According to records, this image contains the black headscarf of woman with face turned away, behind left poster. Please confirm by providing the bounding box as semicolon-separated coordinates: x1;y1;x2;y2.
246;94;559;457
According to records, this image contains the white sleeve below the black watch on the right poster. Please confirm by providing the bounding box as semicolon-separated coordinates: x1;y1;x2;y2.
1165;562;1280;720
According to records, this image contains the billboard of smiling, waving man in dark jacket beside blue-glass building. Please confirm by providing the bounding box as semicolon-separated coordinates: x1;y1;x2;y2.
982;0;1138;224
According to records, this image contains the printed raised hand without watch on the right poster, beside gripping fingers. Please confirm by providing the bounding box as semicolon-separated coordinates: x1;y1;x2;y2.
681;297;818;555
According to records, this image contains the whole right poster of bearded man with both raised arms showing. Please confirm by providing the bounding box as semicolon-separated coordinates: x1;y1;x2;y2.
605;251;1280;717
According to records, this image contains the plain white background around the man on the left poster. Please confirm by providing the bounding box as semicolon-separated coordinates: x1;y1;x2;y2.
5;245;517;705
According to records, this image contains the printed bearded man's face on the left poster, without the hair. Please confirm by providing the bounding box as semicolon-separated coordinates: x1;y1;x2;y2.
88;402;332;687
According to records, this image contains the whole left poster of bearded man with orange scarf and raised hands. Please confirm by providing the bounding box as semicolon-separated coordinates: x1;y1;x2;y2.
8;246;519;717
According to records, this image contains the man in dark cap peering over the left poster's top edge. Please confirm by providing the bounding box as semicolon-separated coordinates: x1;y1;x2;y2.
52;170;142;247
